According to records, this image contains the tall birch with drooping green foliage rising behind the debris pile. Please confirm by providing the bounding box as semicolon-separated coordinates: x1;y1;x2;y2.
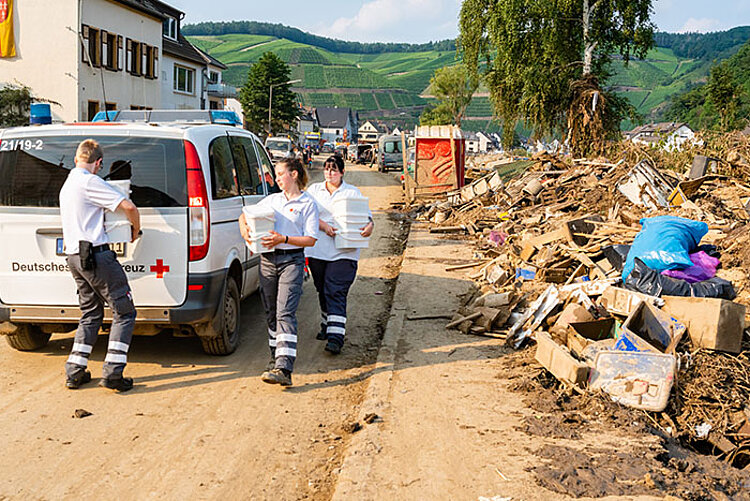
458;0;654;152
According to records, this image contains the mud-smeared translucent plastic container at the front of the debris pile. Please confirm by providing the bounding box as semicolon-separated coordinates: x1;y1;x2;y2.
589;351;676;412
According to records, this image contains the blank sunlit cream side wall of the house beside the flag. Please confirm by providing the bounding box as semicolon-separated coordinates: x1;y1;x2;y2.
0;0;80;121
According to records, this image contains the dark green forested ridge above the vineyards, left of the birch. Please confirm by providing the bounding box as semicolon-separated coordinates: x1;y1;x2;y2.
182;21;456;54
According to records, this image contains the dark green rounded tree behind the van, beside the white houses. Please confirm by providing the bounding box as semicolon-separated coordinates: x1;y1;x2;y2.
239;52;299;134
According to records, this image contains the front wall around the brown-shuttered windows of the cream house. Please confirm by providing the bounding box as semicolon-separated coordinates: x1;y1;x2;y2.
79;0;163;119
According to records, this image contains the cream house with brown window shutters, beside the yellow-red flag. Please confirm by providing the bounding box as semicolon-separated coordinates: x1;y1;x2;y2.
0;0;163;122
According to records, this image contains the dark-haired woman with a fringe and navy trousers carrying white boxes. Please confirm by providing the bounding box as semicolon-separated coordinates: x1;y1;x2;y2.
305;156;373;355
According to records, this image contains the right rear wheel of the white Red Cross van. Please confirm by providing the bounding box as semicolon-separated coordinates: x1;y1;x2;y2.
196;277;240;355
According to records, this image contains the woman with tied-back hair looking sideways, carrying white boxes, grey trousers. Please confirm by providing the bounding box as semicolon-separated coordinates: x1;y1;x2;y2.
240;158;319;386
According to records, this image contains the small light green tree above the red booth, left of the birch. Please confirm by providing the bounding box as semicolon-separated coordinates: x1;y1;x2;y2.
419;64;479;127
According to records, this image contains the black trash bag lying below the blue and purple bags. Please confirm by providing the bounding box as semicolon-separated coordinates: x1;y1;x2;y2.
625;258;737;301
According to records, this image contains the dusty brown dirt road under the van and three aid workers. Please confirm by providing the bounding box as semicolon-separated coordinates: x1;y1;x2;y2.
0;161;405;499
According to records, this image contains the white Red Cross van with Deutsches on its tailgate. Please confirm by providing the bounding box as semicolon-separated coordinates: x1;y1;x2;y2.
0;111;276;355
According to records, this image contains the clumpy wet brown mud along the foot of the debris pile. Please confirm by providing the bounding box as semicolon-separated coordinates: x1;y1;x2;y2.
497;348;750;501
